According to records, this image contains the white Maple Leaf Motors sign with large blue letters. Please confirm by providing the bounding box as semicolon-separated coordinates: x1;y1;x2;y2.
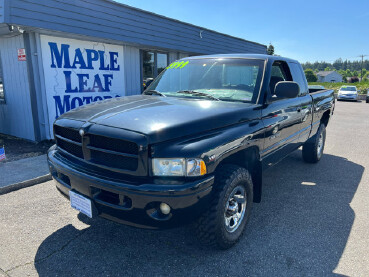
41;35;125;133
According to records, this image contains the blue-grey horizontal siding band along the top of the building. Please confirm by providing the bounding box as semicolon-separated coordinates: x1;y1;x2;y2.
5;0;266;54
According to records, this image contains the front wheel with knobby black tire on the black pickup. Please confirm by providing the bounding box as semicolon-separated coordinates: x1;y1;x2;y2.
196;165;253;249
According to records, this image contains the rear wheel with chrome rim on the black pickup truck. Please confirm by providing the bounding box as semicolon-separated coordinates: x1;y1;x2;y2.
302;123;326;163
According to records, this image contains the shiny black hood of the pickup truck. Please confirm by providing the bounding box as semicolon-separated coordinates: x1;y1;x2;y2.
59;95;256;143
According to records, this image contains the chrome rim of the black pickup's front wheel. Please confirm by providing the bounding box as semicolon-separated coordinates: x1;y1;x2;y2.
224;186;247;233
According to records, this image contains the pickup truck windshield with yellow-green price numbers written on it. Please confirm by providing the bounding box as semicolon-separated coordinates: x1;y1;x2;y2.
146;58;264;103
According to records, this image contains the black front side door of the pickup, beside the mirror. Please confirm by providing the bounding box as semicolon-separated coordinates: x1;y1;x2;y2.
261;61;302;167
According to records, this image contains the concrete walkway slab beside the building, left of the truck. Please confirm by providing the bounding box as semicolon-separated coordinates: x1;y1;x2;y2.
0;155;49;188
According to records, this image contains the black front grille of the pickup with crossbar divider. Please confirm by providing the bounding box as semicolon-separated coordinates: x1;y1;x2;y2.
54;125;140;172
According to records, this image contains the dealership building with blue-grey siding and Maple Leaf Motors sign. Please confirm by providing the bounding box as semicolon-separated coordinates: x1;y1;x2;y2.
0;0;266;141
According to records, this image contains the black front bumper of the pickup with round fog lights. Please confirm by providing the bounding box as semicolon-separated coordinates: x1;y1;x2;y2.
48;149;214;229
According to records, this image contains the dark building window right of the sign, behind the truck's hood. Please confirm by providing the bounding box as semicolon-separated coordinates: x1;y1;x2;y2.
142;51;168;89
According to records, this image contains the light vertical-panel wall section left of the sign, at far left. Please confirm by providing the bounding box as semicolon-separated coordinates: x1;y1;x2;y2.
0;35;35;140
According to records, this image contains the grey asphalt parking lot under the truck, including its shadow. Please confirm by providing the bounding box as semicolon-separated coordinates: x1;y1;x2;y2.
0;102;369;276
